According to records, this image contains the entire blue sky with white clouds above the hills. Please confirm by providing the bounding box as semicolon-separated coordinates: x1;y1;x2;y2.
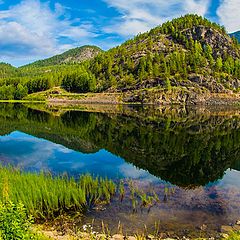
0;0;240;66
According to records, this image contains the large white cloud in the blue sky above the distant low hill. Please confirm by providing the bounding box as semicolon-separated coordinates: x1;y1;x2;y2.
0;0;95;61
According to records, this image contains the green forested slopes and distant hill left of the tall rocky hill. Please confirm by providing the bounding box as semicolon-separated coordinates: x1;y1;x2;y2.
0;46;102;100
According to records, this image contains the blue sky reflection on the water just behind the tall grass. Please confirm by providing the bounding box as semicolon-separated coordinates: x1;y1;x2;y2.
0;131;156;180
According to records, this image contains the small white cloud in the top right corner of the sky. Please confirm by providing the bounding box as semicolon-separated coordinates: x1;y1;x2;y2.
217;0;240;32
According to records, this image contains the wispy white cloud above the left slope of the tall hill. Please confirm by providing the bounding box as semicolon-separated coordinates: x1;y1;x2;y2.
104;0;210;36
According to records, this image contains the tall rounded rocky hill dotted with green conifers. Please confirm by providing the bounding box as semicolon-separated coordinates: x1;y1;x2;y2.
81;15;240;102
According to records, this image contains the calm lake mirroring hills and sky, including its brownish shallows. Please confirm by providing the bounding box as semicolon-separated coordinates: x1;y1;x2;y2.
0;104;240;236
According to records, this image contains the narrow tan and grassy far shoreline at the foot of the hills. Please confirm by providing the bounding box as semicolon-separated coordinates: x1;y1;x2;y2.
0;93;240;107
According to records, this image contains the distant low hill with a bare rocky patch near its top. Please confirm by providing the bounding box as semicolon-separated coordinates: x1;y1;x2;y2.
24;45;102;67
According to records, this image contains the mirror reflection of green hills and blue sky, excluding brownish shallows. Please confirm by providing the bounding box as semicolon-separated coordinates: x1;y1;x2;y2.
0;104;240;188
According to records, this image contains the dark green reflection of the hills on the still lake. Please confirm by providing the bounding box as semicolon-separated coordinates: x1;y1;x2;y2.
0;105;240;187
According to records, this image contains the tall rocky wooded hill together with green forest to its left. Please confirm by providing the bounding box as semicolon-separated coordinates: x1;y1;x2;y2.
0;15;240;102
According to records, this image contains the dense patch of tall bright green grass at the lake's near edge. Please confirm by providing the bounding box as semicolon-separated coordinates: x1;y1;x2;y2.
0;167;116;219
